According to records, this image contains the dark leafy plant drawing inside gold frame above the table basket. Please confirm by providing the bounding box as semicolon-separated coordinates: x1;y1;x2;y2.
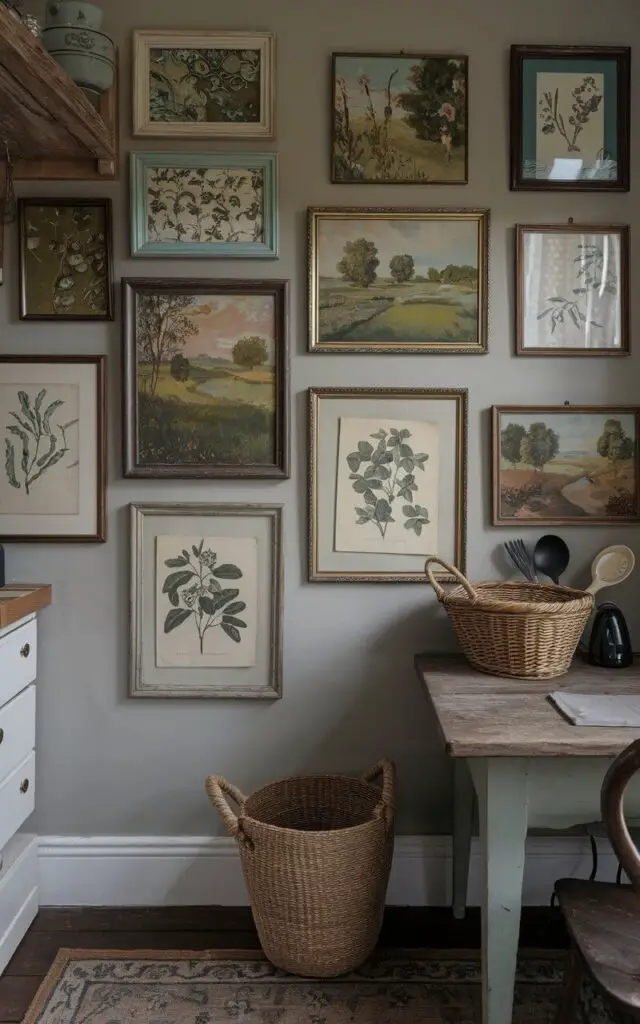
346;427;429;539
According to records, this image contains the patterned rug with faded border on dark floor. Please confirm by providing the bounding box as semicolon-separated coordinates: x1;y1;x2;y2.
24;949;609;1024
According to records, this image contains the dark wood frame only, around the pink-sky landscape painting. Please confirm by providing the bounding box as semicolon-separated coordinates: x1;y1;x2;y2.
122;278;290;479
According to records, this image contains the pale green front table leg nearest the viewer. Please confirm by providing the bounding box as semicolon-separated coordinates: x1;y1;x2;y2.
470;758;528;1024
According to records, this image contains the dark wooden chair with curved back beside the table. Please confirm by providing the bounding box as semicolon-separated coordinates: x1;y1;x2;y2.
556;739;640;1024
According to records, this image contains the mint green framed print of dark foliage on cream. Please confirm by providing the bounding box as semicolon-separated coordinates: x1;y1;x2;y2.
131;153;278;258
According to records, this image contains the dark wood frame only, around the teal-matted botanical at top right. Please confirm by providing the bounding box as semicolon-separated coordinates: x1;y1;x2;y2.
510;45;631;191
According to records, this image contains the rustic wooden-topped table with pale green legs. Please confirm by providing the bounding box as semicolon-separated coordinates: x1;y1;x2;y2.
416;654;640;1024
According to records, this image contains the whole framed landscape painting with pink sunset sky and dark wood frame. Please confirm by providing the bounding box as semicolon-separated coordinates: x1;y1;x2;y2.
122;278;289;478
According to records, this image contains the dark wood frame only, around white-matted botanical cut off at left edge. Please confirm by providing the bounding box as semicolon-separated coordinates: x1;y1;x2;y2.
0;355;106;544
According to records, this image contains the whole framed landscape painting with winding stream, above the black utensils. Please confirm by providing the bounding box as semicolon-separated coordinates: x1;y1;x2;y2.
493;406;640;526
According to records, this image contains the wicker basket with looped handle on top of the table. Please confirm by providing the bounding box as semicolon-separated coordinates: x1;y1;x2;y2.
425;558;593;679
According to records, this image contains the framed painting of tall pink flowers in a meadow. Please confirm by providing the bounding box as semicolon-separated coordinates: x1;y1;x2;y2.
332;53;469;184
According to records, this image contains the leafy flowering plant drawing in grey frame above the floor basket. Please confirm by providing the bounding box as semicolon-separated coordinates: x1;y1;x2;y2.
162;538;247;654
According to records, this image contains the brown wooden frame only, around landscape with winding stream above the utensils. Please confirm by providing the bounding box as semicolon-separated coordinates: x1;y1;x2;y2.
492;404;640;527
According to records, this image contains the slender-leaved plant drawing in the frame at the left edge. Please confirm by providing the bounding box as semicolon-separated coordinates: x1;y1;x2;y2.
4;387;78;494
